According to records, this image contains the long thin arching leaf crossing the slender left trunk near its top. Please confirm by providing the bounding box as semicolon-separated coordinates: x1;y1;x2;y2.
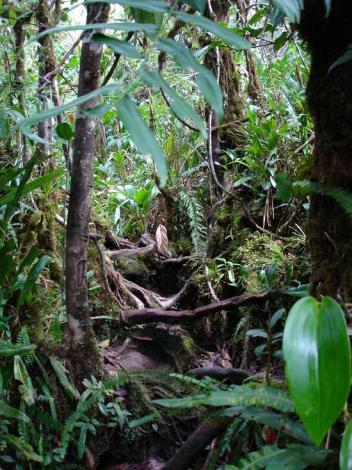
27;22;158;44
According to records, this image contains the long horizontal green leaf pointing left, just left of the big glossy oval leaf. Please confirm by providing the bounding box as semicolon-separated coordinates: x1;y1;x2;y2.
154;385;294;413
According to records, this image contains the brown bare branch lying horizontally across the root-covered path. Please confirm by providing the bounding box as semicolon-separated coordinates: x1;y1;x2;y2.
122;292;273;324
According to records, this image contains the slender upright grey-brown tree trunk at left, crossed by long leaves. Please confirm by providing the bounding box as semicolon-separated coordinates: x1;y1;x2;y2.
66;3;109;381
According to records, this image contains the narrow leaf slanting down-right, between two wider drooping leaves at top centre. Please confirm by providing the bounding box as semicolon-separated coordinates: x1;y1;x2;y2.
138;67;208;139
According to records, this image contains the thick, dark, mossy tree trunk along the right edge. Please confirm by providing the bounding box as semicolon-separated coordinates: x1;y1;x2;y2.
300;0;352;301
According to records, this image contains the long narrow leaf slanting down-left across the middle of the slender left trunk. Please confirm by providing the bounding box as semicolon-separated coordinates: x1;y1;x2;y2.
11;83;121;133
